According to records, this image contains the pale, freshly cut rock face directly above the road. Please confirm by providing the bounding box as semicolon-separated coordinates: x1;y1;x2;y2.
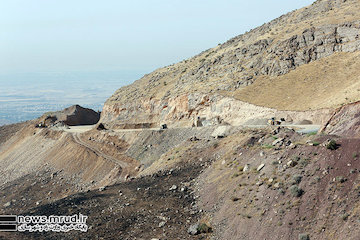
101;94;332;128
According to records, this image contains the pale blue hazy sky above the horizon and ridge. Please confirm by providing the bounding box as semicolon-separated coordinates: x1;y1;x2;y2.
0;0;313;73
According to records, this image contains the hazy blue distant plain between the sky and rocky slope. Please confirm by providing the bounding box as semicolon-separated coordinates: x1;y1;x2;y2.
0;71;145;126
